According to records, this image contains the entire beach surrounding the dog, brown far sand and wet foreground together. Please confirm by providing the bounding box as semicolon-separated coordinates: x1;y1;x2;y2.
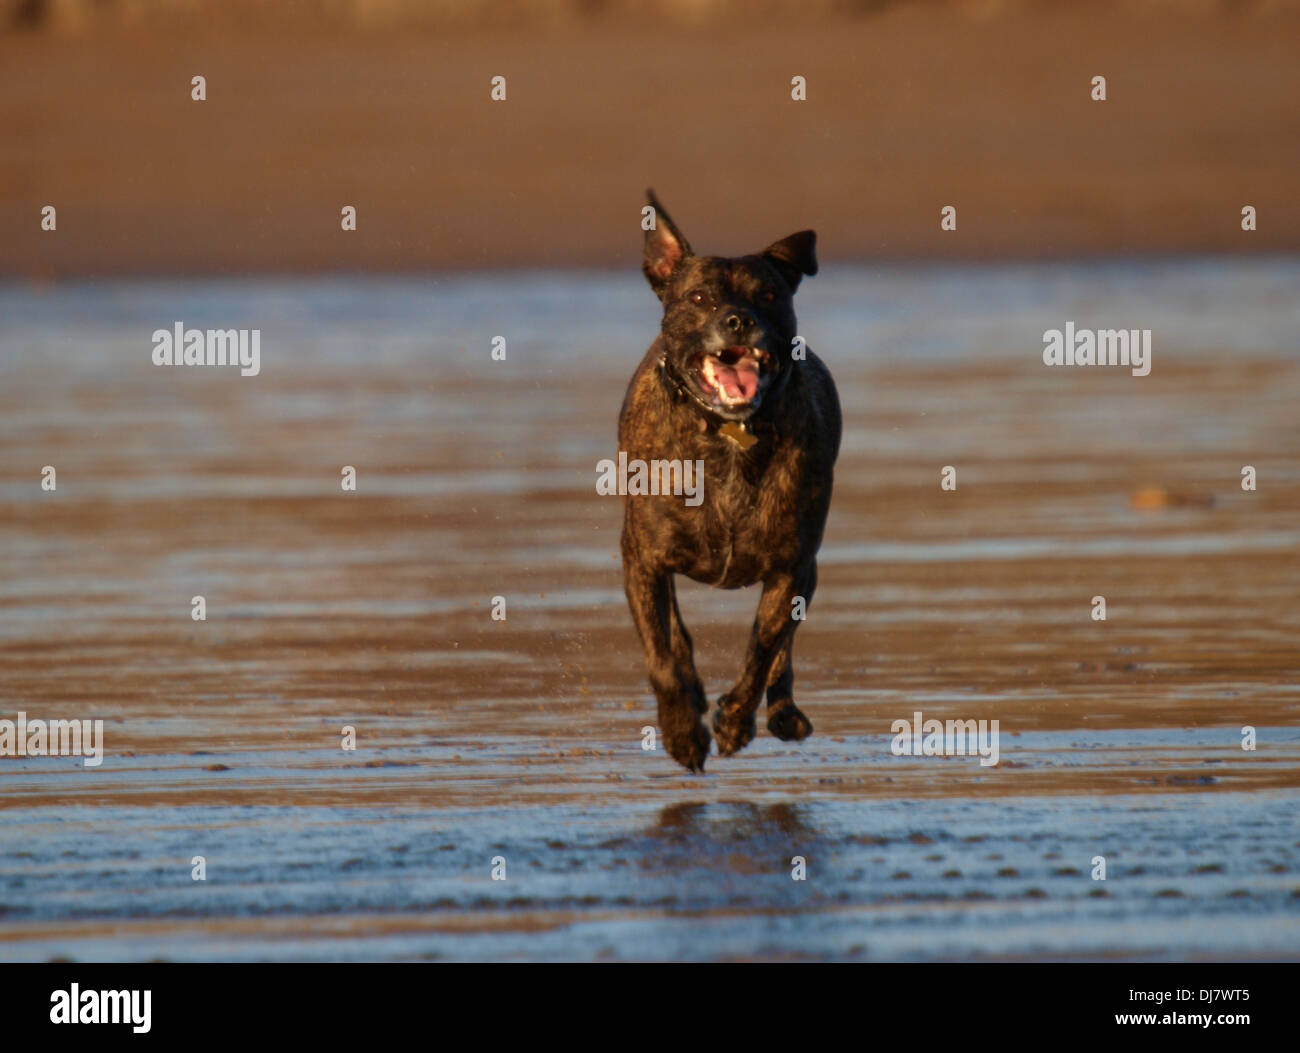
0;0;1300;961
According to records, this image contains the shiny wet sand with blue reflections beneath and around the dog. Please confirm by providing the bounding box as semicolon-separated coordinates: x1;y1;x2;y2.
0;261;1300;959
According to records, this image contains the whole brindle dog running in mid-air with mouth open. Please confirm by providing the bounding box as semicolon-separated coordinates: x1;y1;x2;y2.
619;192;840;771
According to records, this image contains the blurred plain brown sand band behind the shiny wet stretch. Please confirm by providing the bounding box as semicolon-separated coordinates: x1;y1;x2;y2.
0;3;1300;277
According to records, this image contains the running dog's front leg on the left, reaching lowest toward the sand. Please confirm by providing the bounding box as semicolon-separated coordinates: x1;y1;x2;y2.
623;555;710;771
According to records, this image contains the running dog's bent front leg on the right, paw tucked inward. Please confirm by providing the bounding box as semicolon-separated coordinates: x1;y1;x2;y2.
714;563;816;757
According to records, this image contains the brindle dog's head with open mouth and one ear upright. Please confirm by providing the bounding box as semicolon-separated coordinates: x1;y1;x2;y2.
641;191;816;421
